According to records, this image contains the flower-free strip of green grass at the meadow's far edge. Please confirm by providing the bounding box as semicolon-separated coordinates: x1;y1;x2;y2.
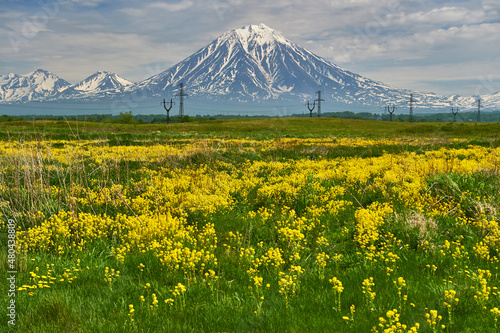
0;118;500;142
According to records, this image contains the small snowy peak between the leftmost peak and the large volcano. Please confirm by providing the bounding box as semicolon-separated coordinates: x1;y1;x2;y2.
73;71;134;94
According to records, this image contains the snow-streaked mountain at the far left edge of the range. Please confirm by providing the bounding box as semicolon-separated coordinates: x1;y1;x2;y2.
0;69;71;102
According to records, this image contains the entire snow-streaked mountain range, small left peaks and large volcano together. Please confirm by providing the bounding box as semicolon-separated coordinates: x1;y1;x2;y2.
0;24;500;110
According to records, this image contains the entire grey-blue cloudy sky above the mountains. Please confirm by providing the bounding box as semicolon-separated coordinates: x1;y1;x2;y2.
0;0;500;96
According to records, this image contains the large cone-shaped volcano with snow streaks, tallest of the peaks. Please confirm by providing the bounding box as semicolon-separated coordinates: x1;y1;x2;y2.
135;24;464;107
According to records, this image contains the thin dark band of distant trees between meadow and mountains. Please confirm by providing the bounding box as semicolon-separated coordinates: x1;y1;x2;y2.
0;111;500;124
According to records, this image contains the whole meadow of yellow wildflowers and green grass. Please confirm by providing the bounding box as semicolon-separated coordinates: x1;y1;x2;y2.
0;118;500;332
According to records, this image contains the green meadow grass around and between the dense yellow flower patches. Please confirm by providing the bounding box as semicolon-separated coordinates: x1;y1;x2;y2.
0;118;500;332
